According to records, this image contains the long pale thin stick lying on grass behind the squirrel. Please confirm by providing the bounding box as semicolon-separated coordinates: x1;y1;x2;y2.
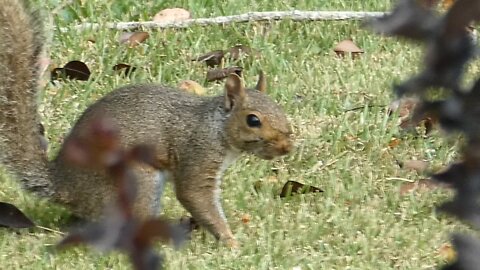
60;10;386;32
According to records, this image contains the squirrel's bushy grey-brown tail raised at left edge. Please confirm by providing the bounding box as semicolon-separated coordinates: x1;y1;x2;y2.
0;0;52;196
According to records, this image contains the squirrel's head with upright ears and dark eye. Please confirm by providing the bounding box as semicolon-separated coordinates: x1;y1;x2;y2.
225;72;293;159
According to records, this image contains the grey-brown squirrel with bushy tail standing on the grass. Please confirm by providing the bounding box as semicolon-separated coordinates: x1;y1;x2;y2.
0;0;293;246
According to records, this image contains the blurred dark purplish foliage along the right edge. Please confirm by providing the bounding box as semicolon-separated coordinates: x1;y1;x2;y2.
370;0;480;270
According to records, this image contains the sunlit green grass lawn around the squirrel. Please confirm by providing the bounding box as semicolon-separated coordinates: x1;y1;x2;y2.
0;0;478;269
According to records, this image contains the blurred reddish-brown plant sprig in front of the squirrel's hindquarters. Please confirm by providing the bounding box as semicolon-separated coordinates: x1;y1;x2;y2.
59;116;188;270
